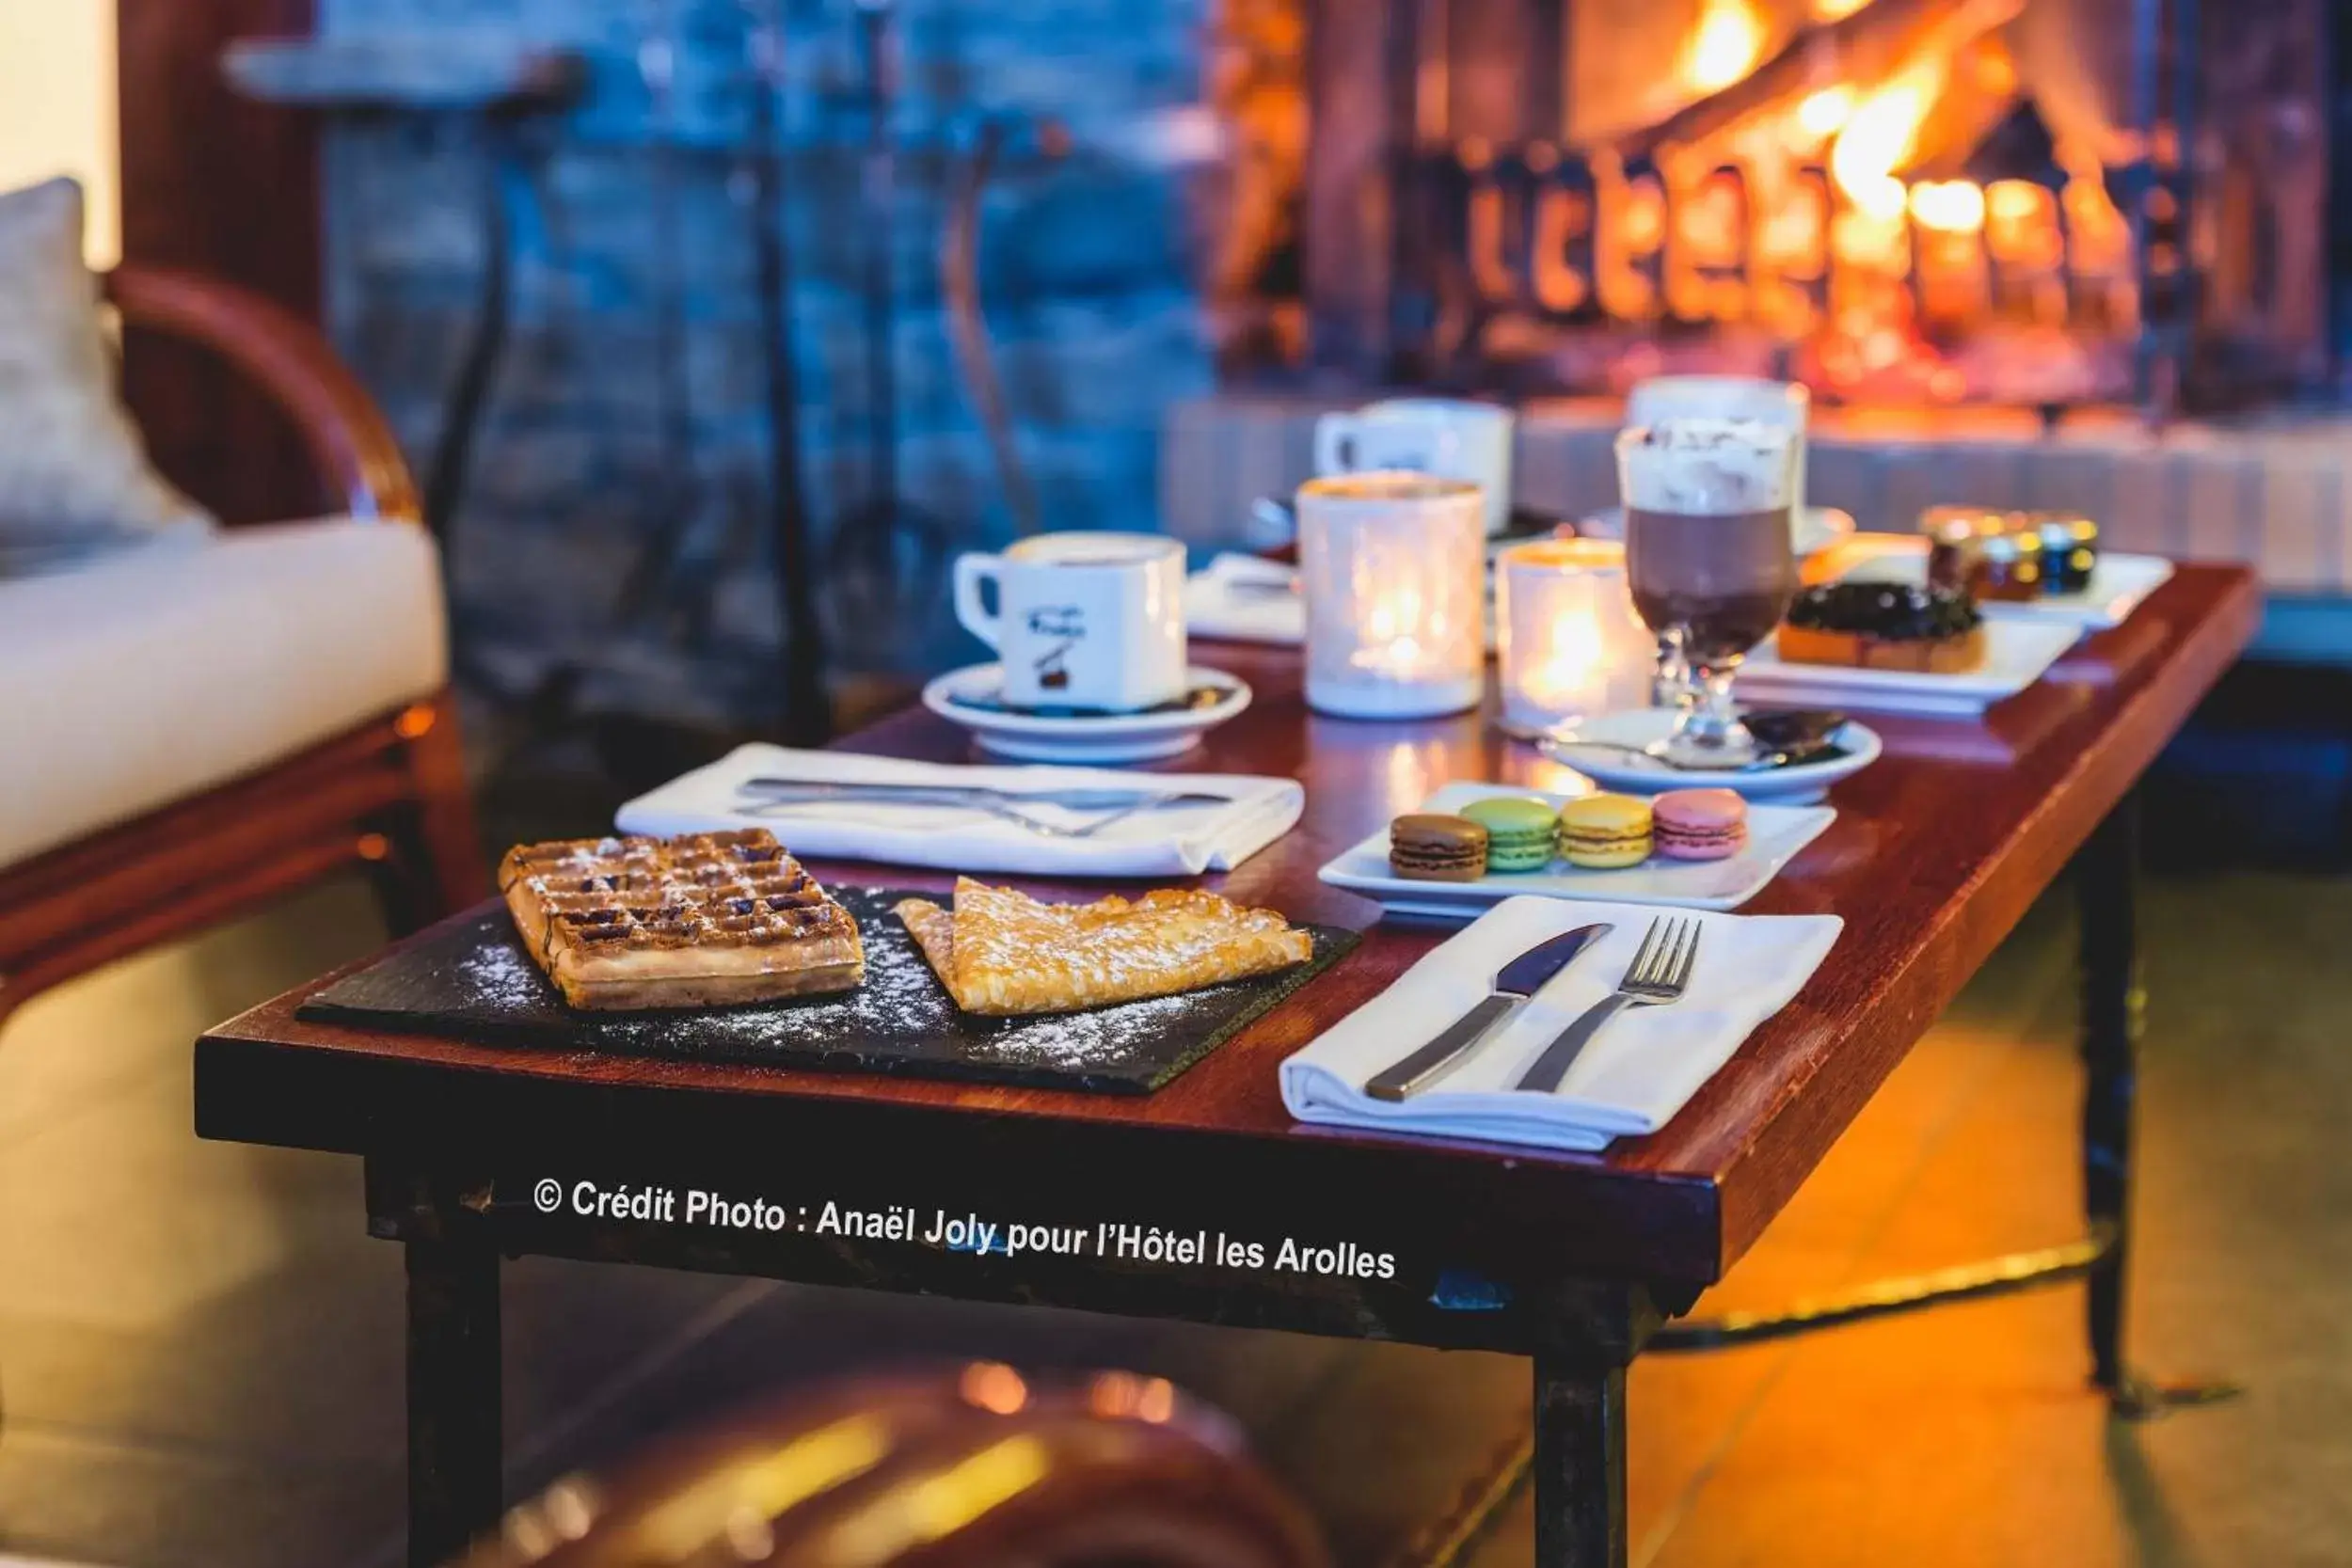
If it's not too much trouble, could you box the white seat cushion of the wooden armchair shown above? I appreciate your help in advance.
[0,522,450,865]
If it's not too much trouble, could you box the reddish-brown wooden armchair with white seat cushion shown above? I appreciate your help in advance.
[0,265,485,1021]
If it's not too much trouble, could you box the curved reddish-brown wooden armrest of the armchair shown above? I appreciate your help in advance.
[106,263,423,522]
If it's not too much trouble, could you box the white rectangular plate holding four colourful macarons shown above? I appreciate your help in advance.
[1322,783,1837,919]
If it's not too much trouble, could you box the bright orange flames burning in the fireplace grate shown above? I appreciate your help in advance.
[1555,0,2138,402]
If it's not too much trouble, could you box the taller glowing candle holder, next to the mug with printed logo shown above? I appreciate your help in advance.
[1298,470,1486,720]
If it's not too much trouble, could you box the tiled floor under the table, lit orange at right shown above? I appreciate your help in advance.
[0,875,2352,1568]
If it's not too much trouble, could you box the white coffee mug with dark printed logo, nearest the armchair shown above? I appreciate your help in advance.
[955,533,1185,712]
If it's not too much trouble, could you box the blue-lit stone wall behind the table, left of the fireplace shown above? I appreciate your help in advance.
[318,0,1212,720]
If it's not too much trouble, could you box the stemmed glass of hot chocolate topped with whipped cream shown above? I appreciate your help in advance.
[1616,416,1802,768]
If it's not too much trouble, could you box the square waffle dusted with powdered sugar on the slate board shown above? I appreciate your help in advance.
[499,828,866,1008]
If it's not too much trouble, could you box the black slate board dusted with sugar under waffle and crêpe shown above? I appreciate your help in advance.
[299,886,1358,1093]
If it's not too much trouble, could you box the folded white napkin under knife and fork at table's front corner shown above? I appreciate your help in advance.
[1282,898,1847,1149]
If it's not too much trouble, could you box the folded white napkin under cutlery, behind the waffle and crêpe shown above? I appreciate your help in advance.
[616,745,1308,877]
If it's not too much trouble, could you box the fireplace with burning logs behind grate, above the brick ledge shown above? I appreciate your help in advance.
[1223,0,2341,414]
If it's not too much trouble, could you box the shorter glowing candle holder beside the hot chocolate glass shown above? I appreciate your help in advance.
[1494,538,1659,738]
